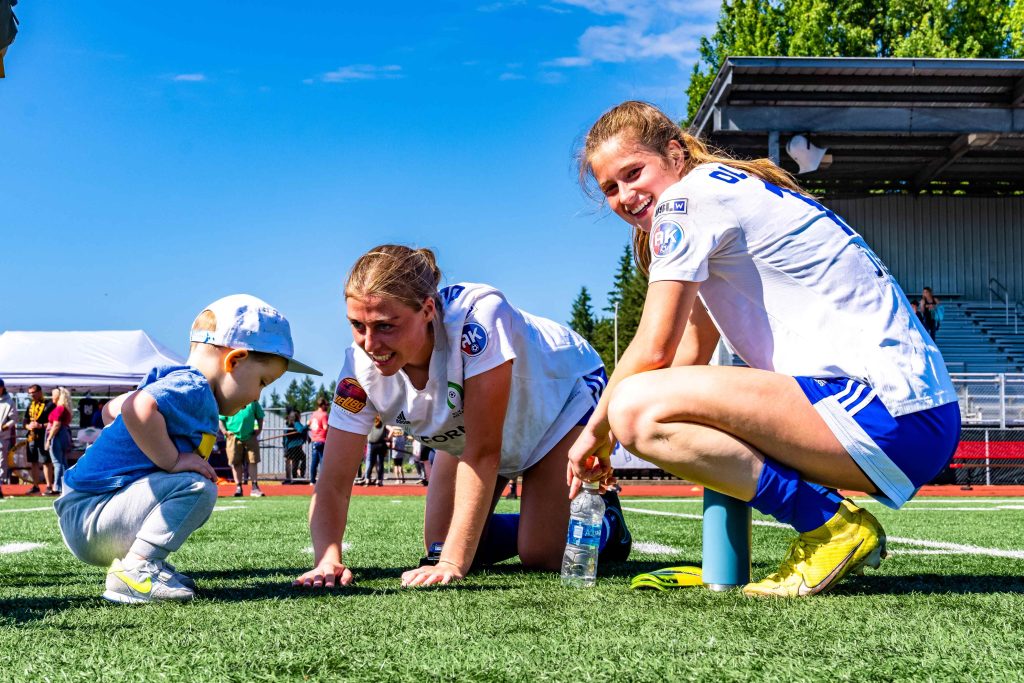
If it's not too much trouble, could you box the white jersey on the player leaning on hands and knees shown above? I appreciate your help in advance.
[330,283,604,475]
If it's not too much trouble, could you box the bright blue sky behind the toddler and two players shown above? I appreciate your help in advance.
[0,0,720,393]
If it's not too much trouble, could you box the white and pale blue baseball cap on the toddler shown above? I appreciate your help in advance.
[188,294,324,376]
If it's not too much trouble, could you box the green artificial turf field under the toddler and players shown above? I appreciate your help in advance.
[0,498,1024,681]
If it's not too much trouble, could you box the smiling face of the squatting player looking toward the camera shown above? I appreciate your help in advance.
[590,135,683,232]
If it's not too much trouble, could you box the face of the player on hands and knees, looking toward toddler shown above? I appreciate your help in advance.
[346,295,434,376]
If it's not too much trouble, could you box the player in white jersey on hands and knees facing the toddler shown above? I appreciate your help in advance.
[295,245,632,588]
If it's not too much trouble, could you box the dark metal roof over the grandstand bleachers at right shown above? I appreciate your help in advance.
[690,57,1024,196]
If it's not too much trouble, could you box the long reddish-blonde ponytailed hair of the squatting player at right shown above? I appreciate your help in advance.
[577,100,806,274]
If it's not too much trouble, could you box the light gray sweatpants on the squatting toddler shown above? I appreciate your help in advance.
[54,472,217,566]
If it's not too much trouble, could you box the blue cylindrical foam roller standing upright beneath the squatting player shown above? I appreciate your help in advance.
[701,488,752,591]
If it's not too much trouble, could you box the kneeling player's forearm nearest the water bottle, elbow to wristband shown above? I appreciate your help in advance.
[440,452,501,572]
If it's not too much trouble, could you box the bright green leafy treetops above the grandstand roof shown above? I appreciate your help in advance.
[686,0,1024,121]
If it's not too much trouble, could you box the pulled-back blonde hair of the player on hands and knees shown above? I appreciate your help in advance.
[345,245,441,311]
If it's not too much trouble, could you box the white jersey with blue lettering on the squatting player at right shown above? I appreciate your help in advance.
[650,164,956,416]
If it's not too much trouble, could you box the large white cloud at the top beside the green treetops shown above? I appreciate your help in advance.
[546,0,721,68]
